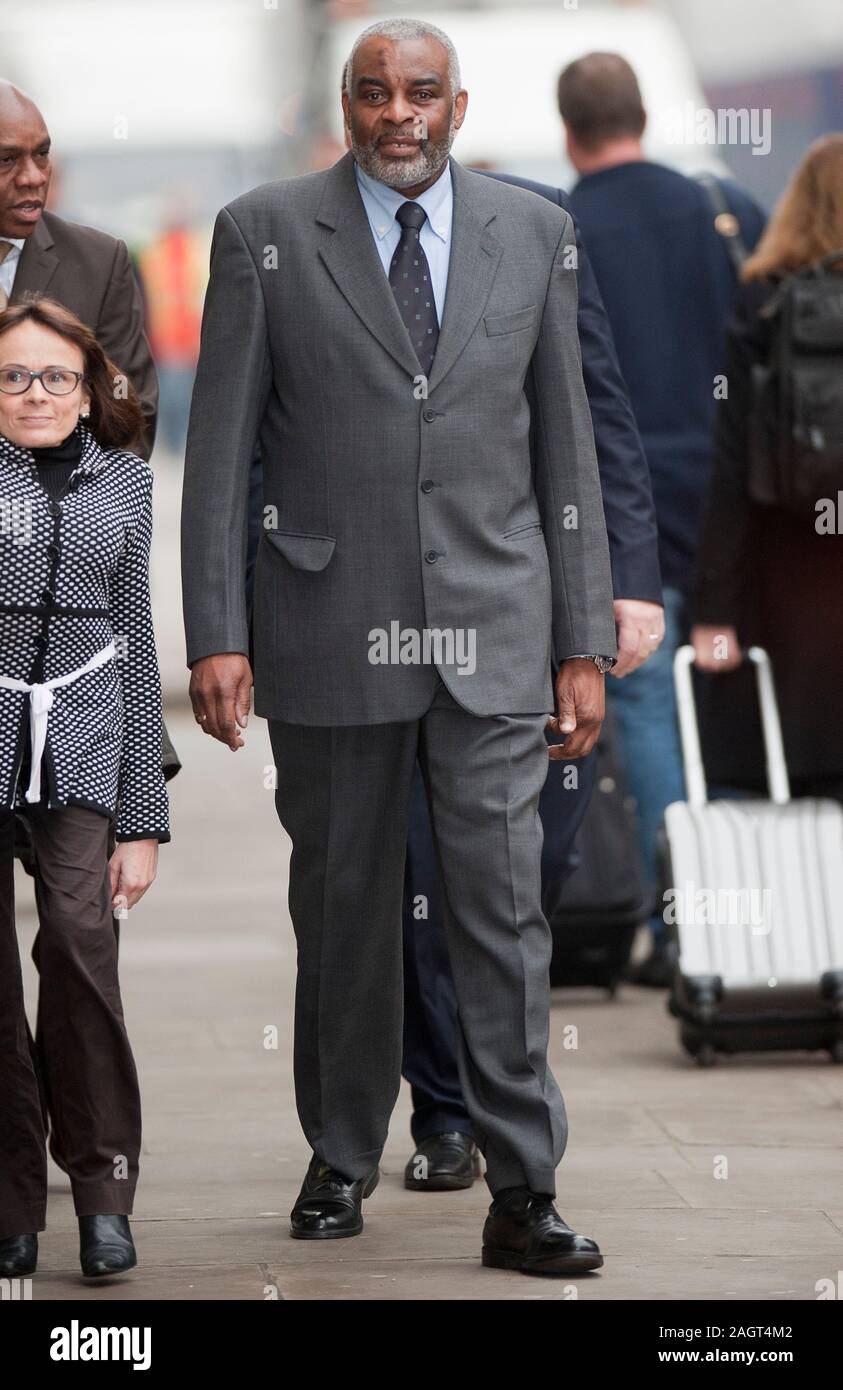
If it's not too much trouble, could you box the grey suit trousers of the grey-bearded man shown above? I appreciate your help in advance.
[268,680,568,1194]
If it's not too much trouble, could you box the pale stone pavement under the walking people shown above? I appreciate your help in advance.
[18,708,843,1301]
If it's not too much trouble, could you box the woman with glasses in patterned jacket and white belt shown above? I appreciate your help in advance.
[0,297,170,1276]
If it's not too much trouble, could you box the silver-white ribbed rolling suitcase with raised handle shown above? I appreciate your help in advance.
[662,646,843,1066]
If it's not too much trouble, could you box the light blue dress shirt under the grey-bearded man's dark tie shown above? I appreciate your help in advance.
[355,161,453,327]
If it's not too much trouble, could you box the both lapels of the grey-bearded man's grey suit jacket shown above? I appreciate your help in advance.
[316,152,504,392]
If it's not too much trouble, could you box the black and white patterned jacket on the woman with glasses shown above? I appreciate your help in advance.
[0,421,170,841]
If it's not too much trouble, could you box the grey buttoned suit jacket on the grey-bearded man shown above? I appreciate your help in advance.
[182,154,616,724]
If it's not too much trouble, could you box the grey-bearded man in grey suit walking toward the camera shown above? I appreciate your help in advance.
[182,19,616,1275]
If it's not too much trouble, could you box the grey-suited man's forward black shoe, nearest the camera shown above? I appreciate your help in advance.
[483,1187,602,1275]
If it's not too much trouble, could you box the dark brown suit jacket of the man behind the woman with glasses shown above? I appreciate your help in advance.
[10,213,159,460]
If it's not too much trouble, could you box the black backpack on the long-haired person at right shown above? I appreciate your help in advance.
[747,250,843,513]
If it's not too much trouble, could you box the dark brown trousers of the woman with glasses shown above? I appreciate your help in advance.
[0,803,141,1240]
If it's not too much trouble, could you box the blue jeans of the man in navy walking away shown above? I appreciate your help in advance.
[607,588,686,941]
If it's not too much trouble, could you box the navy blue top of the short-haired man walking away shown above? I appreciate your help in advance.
[569,160,764,592]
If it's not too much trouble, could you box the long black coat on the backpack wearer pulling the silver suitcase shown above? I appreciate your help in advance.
[693,281,843,790]
